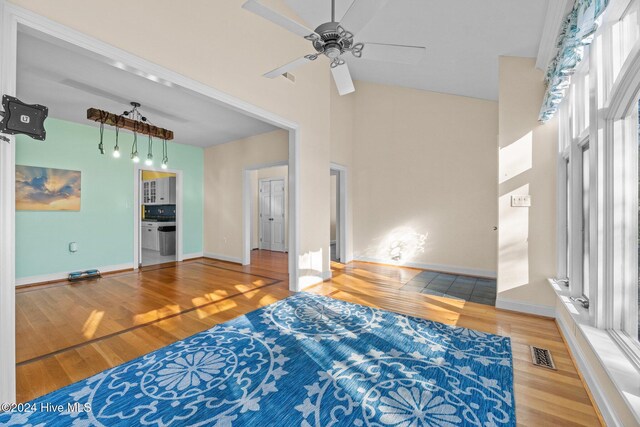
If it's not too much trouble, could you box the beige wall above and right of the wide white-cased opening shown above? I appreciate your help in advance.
[12,0,330,285]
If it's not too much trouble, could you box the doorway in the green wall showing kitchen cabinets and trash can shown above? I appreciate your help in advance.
[136,169,178,267]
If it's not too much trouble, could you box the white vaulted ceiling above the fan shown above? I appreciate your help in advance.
[285,0,554,100]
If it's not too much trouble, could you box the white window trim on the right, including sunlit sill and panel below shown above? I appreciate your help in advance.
[550,0,640,425]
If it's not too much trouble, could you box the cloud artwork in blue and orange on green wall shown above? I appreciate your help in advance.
[16,165,81,211]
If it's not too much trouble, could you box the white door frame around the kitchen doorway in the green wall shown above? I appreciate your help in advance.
[133,164,184,269]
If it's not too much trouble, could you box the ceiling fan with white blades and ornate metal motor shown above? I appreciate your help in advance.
[242,0,426,95]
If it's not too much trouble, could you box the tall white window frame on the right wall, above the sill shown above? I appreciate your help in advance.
[557,0,640,371]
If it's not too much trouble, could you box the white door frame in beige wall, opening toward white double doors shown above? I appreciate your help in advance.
[242,162,288,266]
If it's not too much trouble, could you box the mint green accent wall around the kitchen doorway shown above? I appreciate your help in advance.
[16,118,204,279]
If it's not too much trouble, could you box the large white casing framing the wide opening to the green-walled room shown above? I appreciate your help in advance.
[0,0,300,402]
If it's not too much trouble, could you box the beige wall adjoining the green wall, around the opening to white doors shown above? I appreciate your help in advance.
[204,130,288,262]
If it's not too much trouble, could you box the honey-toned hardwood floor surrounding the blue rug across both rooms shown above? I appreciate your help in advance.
[16,251,600,426]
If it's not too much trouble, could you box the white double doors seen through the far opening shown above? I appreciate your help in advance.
[259,179,285,252]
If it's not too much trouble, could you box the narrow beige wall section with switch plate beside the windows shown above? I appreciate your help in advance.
[497,57,558,314]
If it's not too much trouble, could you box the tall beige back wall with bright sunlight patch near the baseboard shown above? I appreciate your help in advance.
[350,81,498,275]
